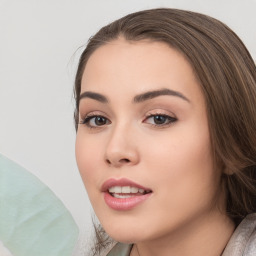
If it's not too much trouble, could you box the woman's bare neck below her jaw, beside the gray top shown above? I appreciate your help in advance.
[131,212,234,256]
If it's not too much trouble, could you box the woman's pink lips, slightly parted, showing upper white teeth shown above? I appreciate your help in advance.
[101,179,152,211]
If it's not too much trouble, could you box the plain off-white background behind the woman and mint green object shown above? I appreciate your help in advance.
[0,0,256,240]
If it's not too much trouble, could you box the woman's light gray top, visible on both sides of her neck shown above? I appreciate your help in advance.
[107,213,256,256]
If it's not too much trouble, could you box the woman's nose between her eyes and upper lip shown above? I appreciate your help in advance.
[105,124,139,168]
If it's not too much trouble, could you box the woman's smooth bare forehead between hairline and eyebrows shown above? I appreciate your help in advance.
[81,38,203,104]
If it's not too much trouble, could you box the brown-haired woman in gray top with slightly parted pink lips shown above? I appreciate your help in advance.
[75,9,256,256]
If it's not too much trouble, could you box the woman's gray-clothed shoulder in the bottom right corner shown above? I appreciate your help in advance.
[222,213,256,256]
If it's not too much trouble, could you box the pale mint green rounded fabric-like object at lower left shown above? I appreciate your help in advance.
[0,154,78,256]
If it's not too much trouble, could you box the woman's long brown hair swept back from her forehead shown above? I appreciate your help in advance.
[74,8,256,253]
